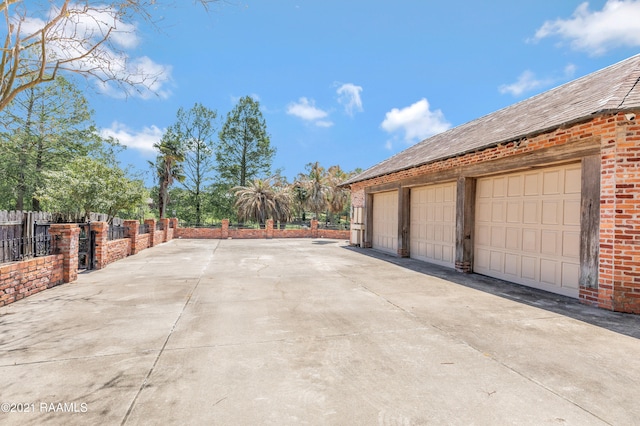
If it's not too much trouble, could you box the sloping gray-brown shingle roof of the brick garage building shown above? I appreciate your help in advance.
[343,54,640,185]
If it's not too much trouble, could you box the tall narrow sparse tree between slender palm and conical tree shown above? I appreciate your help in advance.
[173,103,218,225]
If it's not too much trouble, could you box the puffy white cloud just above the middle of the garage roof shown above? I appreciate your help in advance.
[380,98,451,147]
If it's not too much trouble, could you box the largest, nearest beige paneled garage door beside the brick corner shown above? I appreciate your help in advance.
[474,164,581,297]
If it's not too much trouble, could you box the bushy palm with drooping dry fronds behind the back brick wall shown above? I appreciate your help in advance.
[233,177,291,225]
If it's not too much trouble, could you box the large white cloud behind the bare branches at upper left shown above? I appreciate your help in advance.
[18,3,172,99]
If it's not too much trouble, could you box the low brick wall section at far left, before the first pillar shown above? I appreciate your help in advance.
[0,254,64,306]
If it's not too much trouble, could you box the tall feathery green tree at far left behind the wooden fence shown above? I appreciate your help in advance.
[0,77,115,210]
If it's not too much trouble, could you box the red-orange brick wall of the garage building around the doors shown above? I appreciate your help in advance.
[351,111,640,313]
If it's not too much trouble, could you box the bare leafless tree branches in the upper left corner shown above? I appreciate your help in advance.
[0,0,219,111]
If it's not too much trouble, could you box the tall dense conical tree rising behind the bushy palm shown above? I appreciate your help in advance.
[216,96,276,187]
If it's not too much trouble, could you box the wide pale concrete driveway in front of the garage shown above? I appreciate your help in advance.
[0,239,640,425]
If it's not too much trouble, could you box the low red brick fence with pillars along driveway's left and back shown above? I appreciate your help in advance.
[0,218,349,306]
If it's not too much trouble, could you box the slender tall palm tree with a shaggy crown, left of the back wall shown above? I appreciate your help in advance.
[152,129,185,219]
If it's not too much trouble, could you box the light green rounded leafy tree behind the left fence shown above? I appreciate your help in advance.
[35,158,148,220]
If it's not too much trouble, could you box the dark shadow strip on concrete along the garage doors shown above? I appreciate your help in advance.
[344,246,640,339]
